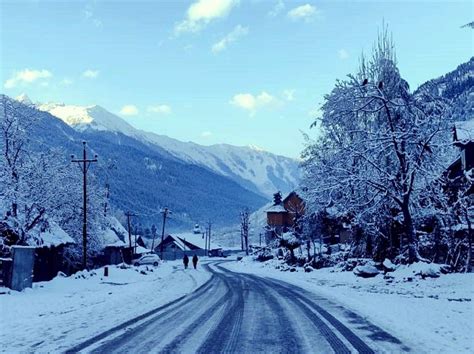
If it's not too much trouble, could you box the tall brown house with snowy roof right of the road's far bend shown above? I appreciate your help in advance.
[266,191,305,234]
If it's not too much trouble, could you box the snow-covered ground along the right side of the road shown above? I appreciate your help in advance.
[225,257,474,353]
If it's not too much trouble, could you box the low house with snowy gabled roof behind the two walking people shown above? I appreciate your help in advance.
[154,232,222,260]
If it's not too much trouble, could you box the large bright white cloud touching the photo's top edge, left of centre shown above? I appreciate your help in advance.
[174,0,239,35]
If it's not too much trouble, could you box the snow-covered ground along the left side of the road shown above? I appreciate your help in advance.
[0,261,210,353]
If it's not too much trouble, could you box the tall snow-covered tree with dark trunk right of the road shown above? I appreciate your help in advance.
[303,29,449,262]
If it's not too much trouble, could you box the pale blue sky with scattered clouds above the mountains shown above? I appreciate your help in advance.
[0,0,474,157]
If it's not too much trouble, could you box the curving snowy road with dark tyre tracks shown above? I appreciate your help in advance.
[70,262,409,353]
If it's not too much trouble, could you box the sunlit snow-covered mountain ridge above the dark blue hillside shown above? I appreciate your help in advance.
[31,95,299,197]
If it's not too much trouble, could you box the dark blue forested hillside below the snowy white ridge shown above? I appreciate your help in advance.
[3,96,265,229]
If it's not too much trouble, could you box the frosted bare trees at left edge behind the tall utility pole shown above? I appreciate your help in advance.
[0,95,106,262]
